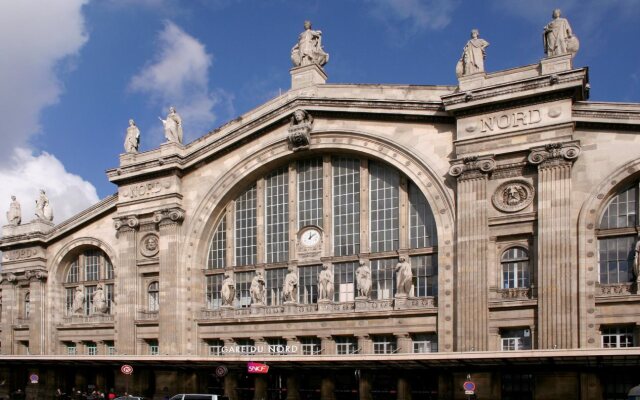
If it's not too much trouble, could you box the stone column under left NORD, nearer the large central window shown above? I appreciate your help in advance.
[153,208,188,355]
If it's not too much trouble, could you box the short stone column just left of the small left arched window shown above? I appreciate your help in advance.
[24,269,47,355]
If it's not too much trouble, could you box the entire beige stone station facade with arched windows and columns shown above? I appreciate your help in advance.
[0,21,640,400]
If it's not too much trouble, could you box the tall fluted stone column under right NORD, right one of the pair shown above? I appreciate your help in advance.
[528,142,580,349]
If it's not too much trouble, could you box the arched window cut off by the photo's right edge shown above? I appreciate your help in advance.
[597,181,640,285]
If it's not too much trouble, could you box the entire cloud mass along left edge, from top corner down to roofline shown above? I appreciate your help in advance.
[0,0,98,225]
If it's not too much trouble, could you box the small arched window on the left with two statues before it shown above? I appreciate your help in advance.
[64,249,114,316]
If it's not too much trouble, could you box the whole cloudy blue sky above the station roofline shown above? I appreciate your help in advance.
[0,0,640,224]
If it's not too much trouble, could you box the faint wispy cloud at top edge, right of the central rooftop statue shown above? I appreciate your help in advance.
[367,0,459,37]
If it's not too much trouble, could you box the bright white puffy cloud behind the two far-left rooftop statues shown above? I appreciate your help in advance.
[0,149,98,225]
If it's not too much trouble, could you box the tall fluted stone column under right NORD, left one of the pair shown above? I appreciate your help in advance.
[449,156,496,351]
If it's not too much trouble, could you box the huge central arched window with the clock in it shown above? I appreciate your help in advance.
[205,155,438,309]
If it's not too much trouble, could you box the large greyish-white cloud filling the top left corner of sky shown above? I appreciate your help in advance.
[0,0,88,161]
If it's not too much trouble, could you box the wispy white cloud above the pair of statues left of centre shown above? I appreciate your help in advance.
[129,21,224,140]
